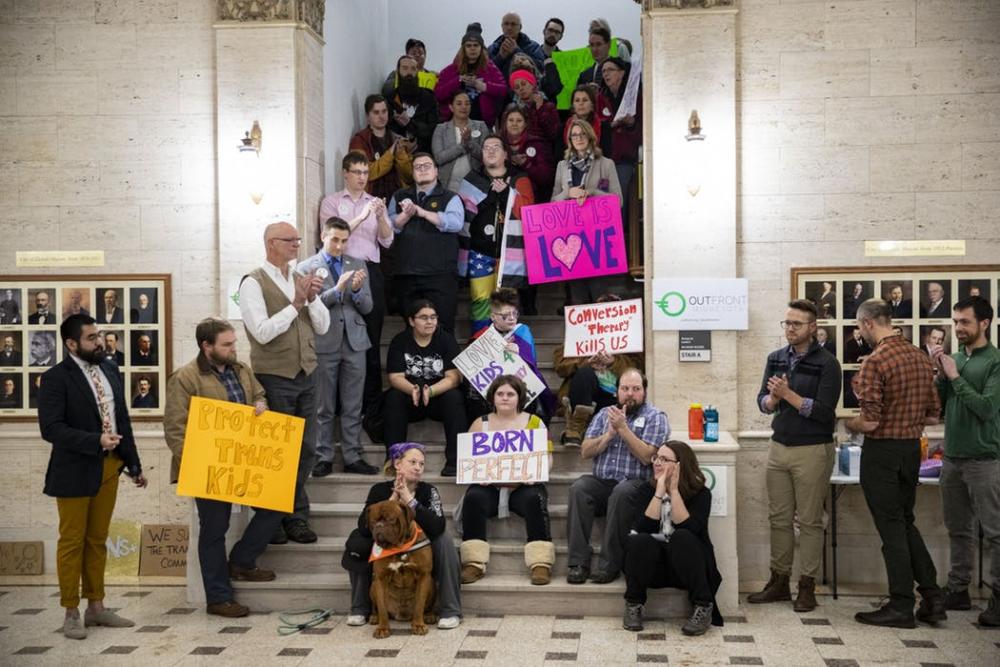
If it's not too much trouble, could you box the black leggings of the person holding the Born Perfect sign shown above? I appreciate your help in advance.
[462,484,552,542]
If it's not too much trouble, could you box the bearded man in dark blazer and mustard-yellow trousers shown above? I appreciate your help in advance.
[38,314,146,639]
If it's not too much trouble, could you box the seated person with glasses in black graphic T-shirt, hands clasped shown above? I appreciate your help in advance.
[383,299,467,477]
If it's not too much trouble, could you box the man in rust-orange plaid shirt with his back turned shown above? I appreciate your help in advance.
[847,299,947,628]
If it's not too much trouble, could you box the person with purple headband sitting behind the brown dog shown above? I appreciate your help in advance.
[341,442,462,630]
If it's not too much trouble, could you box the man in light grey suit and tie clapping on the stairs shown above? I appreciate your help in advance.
[295,217,378,477]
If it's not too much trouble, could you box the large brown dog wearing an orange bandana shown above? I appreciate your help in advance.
[368,500,436,639]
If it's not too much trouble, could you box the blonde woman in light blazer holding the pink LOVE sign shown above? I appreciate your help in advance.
[552,118,622,304]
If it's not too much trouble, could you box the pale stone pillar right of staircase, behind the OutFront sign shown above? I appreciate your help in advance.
[642,0,738,430]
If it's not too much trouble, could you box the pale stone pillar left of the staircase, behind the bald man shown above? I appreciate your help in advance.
[215,0,324,315]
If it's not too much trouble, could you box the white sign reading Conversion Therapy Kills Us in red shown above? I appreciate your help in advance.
[563,299,643,357]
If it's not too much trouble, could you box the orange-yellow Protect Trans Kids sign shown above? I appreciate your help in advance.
[177,396,306,512]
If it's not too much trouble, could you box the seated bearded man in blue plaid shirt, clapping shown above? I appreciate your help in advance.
[566,368,670,584]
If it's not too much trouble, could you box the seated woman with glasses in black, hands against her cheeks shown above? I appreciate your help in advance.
[622,440,722,635]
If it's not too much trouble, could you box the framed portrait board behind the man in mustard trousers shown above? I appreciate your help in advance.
[0,274,171,421]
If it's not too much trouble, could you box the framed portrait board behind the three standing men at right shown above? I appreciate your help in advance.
[792,266,1000,417]
